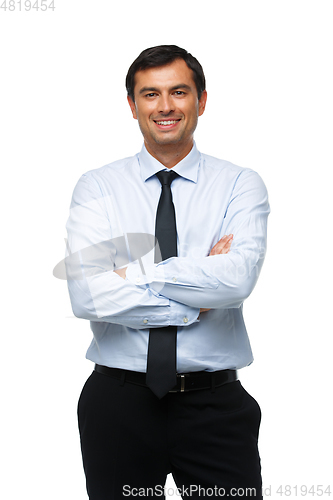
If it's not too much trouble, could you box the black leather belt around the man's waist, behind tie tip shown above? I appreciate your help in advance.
[95,365,237,392]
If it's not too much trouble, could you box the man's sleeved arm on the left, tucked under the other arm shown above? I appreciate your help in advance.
[67,175,199,329]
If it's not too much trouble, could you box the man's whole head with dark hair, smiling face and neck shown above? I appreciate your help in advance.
[126,45,207,166]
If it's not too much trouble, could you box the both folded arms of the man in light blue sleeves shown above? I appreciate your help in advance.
[67,166,269,329]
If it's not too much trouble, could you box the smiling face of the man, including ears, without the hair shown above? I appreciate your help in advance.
[128,59,207,152]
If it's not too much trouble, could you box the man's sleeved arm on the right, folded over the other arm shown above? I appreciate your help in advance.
[126,169,270,309]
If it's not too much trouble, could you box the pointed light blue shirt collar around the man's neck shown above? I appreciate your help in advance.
[138,142,200,182]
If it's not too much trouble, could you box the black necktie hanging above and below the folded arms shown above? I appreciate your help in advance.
[146,170,178,398]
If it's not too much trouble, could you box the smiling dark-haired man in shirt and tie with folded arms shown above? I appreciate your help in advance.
[67,45,269,500]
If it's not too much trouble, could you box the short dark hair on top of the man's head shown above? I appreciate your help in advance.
[126,45,206,101]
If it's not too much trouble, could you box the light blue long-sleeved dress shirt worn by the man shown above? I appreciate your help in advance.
[67,144,269,373]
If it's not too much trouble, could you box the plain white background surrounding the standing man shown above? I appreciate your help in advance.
[0,0,333,500]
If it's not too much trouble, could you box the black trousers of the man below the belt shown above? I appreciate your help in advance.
[78,371,262,500]
